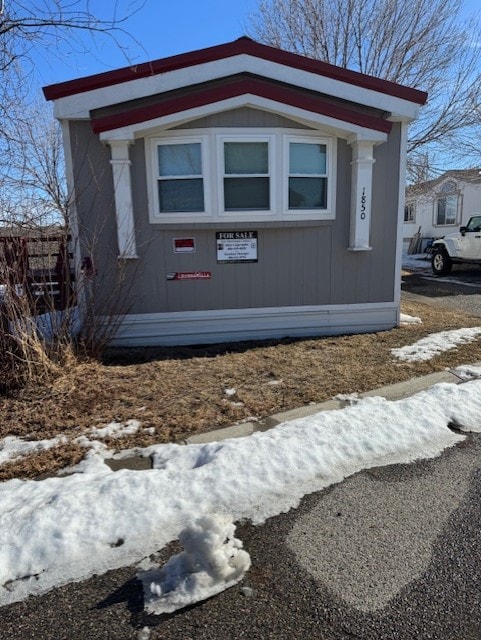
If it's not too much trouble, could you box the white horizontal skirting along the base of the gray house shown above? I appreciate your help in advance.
[104,302,399,347]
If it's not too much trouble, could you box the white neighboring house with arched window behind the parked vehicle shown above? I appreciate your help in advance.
[403,169,481,249]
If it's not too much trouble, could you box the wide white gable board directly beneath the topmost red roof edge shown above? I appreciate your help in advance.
[54,54,419,121]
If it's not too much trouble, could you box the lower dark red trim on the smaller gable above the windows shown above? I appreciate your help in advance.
[92,78,392,133]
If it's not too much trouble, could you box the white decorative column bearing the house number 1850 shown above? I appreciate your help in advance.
[349,138,376,251]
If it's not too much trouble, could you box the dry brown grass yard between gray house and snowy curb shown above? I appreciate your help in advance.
[0,302,481,480]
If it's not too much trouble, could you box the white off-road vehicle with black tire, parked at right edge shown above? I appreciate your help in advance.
[431,213,481,276]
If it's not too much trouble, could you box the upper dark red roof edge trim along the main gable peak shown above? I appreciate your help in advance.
[43,37,427,104]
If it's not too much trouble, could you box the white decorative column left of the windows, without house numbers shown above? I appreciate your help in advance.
[108,140,138,259]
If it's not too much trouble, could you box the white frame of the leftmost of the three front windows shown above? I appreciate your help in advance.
[147,135,212,222]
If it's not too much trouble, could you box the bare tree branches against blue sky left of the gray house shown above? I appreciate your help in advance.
[0,0,145,226]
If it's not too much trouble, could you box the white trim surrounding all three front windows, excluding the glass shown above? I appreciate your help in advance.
[145,128,337,224]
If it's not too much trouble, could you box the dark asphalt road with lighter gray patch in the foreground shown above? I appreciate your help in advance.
[0,434,481,640]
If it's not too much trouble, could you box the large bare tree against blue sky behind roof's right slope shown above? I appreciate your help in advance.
[248,0,481,170]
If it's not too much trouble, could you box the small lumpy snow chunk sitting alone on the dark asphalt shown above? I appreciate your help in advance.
[139,515,251,614]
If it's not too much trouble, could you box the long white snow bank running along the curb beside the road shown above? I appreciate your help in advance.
[0,380,481,605]
